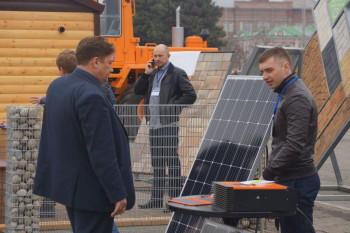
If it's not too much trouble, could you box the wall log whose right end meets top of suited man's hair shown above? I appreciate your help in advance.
[0,39,80,50]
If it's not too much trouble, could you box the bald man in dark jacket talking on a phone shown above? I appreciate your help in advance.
[135,44,197,209]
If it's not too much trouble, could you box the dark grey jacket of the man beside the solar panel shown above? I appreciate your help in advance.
[263,74,318,182]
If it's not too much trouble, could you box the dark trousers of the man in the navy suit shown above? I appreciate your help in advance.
[66,206,113,233]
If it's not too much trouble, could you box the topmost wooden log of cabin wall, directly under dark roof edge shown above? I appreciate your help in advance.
[0,11,94,22]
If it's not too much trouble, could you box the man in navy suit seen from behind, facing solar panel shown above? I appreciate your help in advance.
[34,36,135,233]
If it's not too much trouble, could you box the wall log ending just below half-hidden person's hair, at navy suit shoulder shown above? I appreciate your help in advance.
[0,75,58,86]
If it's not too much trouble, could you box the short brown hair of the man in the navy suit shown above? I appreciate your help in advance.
[76,36,115,65]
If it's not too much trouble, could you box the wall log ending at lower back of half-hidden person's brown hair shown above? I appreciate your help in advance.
[0,66,60,76]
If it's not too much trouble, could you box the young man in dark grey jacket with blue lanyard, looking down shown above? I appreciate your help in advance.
[259,47,320,233]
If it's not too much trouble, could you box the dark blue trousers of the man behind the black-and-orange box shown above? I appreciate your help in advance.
[279,174,320,233]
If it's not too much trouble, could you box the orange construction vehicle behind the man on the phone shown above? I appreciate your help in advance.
[94,0,218,104]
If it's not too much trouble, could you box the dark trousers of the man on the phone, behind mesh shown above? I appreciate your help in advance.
[150,126,181,201]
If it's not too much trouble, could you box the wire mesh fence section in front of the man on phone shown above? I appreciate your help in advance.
[116,105,215,232]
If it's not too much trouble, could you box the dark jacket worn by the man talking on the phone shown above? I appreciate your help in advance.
[135,63,197,125]
